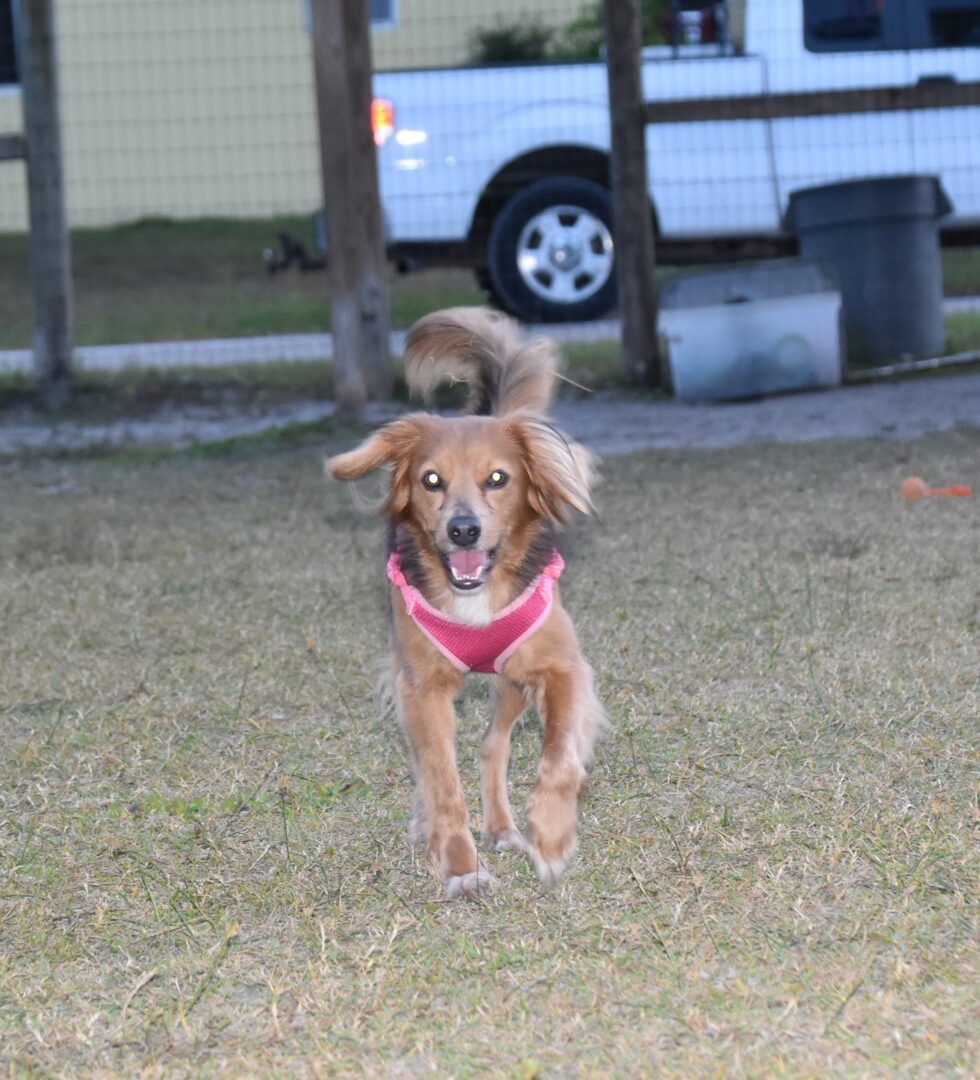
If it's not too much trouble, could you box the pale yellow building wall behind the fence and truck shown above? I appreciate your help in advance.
[0,0,581,231]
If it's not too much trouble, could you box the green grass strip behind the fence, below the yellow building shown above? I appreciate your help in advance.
[0,217,980,349]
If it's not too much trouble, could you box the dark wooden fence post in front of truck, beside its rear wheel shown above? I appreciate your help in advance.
[603,0,660,384]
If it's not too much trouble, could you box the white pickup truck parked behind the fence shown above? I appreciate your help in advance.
[373,0,980,321]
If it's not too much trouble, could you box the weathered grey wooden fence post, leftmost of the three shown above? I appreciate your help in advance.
[15,0,72,408]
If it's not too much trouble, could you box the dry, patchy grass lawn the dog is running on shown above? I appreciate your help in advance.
[0,428,980,1078]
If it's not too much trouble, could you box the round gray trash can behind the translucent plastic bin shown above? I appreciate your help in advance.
[787,176,952,365]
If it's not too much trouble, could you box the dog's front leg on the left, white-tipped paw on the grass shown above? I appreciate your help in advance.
[397,674,497,900]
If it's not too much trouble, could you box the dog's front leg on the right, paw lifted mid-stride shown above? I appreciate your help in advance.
[527,663,601,885]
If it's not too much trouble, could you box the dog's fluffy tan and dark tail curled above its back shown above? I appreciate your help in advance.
[405,308,558,416]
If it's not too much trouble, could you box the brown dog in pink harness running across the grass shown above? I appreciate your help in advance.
[327,308,604,897]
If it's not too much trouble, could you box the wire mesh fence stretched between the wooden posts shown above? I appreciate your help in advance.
[0,0,980,367]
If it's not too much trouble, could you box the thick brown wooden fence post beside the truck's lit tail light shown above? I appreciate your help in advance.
[311,0,391,413]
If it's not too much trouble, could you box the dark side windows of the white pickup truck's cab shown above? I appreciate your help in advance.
[803,0,980,53]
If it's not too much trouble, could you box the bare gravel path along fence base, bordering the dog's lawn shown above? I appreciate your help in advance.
[0,372,980,456]
